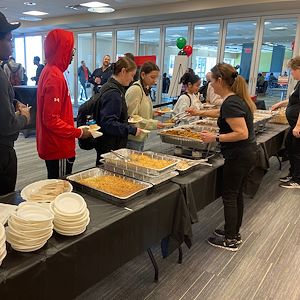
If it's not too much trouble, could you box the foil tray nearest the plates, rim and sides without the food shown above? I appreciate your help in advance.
[66,168,152,205]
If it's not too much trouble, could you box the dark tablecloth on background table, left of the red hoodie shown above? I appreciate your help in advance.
[14,85,37,129]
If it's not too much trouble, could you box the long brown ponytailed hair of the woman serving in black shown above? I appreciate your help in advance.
[211,63,256,113]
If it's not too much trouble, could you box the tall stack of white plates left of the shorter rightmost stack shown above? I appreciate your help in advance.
[6,202,54,252]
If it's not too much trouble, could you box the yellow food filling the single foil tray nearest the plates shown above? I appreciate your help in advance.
[79,175,144,198]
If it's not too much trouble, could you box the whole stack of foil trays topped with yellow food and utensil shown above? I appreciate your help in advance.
[101,149,179,185]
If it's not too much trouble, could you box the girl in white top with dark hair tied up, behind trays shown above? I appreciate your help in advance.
[173,72,201,122]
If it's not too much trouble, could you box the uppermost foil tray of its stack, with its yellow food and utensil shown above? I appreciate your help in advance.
[101,148,178,176]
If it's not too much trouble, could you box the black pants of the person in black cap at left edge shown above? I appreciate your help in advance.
[0,145,17,196]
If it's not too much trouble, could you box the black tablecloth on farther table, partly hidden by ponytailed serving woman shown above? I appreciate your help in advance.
[172,124,289,219]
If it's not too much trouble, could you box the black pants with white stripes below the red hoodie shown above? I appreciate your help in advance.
[45,157,75,179]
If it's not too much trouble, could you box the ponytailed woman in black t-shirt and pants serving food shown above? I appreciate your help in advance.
[188,63,256,251]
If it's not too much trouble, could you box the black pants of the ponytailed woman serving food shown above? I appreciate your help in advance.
[222,145,257,239]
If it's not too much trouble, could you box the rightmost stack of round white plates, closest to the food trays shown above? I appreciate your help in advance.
[50,193,90,236]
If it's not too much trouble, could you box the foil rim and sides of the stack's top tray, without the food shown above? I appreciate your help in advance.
[101,148,178,176]
